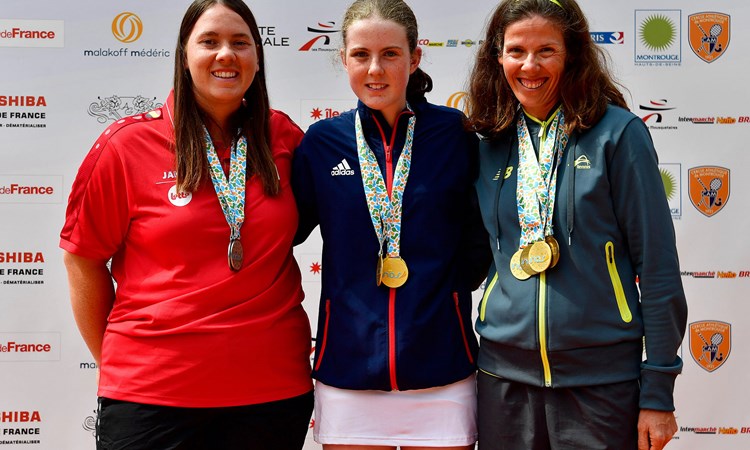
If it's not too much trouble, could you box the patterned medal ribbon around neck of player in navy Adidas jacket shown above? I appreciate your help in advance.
[354,109,417,257]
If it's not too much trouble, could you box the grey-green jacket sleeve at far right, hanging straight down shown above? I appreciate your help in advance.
[609,117,687,411]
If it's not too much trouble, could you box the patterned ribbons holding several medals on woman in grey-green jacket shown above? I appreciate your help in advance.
[516,108,568,248]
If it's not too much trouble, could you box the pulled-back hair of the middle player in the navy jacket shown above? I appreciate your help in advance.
[341,0,432,102]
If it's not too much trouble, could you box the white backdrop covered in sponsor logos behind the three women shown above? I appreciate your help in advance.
[0,0,750,450]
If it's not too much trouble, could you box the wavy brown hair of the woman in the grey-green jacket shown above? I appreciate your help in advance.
[468,0,628,138]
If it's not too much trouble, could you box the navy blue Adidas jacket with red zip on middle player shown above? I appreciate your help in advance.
[293,101,490,390]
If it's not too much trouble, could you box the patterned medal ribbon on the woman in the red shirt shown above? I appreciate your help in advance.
[204,128,247,240]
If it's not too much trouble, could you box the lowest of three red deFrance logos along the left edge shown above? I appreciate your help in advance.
[0,333,60,362]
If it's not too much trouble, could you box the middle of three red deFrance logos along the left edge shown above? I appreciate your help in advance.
[0,175,63,203]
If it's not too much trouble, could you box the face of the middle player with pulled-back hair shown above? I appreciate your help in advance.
[341,17,422,125]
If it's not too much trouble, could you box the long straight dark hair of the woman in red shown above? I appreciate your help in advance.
[174,0,279,196]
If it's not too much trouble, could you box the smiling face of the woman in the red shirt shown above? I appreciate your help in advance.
[185,4,259,113]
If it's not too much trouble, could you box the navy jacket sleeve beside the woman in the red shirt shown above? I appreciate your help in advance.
[292,132,319,245]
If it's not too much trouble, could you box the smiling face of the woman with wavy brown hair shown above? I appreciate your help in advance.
[498,16,565,120]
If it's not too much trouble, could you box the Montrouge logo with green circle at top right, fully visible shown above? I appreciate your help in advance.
[634,9,682,66]
